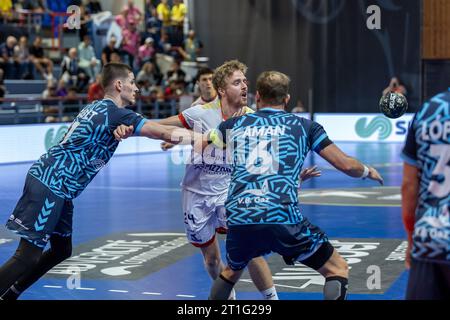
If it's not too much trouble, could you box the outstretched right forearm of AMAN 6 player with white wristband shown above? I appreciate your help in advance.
[319,143,383,185]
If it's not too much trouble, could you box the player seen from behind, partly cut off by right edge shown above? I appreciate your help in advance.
[402,91,450,300]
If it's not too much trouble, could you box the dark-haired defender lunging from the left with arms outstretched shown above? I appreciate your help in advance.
[0,63,181,299]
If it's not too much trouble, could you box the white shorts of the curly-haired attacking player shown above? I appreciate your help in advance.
[182,189,227,247]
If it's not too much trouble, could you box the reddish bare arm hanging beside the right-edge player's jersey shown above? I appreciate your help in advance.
[402,162,419,268]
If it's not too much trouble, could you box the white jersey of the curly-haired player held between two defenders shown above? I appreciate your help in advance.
[178,99,253,196]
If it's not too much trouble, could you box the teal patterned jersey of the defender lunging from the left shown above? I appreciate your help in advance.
[28,99,146,199]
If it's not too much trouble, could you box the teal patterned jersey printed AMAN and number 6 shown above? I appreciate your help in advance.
[212,108,332,225]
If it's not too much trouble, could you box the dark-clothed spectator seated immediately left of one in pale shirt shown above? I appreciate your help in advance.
[61,48,89,92]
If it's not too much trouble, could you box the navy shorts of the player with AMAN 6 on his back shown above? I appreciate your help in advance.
[226,218,333,270]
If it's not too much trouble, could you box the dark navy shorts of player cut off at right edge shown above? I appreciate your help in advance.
[406,258,450,300]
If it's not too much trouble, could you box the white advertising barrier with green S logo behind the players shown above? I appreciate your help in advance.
[0,114,413,163]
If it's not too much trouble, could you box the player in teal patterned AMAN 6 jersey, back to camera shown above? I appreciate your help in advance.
[207,71,383,300]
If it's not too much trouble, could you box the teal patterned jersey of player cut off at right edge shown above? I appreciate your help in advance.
[402,91,450,263]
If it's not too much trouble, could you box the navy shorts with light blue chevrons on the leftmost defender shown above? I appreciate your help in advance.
[6,174,73,248]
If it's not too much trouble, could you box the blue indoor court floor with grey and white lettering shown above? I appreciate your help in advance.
[0,142,407,300]
